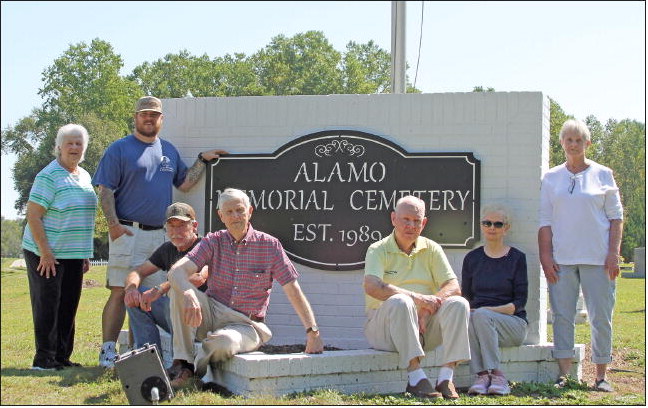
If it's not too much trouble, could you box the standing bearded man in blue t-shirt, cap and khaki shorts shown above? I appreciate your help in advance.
[92,96,226,368]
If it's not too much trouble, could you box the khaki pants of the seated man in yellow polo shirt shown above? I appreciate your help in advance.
[365,294,470,367]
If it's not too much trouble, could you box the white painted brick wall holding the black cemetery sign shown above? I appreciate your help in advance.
[161,92,549,348]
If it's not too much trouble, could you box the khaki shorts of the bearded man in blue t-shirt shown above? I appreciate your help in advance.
[106,225,166,288]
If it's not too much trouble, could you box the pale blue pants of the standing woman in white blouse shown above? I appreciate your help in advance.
[549,265,616,364]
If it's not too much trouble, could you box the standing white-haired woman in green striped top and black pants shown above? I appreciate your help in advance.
[22,124,97,370]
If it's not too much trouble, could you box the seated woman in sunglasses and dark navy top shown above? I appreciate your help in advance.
[461,205,528,395]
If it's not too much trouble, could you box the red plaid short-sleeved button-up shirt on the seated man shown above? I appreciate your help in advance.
[187,225,299,318]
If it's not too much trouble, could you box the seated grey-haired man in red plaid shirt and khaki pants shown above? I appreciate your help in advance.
[169,188,324,387]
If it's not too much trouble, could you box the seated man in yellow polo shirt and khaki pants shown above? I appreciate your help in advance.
[364,196,470,399]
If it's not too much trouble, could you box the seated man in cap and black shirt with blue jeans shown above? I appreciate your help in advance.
[124,203,207,365]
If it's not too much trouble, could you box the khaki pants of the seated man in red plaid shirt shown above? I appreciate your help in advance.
[169,287,272,363]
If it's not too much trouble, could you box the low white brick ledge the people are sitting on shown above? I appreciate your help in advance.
[118,330,585,396]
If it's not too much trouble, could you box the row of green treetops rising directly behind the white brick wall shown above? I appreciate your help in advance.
[129,31,420,98]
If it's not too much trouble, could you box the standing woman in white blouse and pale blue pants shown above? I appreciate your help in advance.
[538,119,623,391]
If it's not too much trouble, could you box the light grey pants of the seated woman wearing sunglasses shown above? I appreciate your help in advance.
[468,308,527,374]
